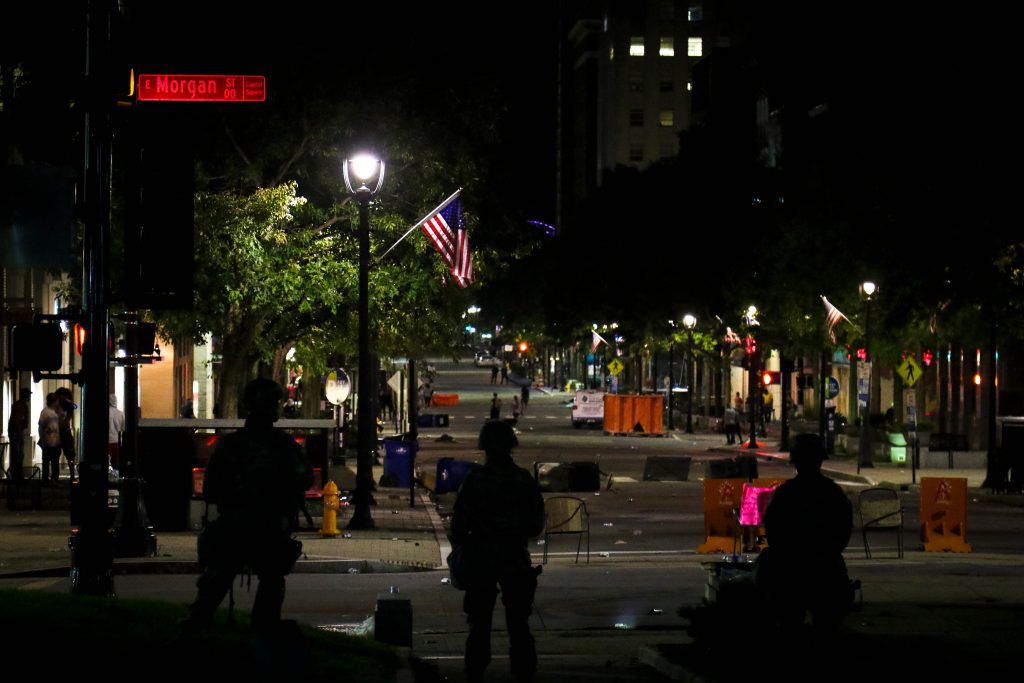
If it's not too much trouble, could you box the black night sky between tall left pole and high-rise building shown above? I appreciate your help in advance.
[123,0,557,220]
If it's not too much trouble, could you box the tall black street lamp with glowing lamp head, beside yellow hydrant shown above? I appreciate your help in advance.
[343,154,384,529]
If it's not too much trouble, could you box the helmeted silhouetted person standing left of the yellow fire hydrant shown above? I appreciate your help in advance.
[182,380,313,638]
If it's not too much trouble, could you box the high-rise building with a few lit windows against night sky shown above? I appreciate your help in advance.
[558,0,741,229]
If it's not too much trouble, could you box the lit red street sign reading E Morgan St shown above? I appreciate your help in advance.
[136,74,266,102]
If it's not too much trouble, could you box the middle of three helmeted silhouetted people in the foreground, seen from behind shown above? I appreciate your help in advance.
[450,421,544,683]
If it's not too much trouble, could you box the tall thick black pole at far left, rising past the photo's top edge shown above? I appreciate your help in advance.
[71,0,114,596]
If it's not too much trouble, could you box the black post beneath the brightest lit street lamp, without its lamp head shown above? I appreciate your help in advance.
[347,197,377,529]
